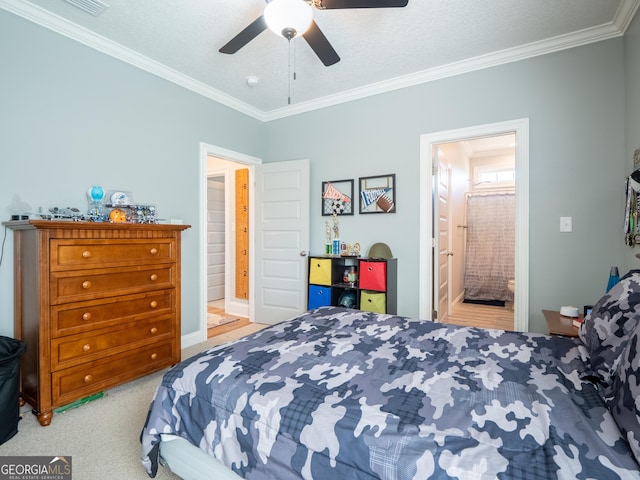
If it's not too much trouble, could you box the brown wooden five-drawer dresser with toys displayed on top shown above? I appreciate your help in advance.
[5,220,189,426]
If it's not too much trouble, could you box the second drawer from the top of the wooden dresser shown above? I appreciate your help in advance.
[50,265,175,305]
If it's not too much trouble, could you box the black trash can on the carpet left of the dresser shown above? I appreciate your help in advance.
[0,335,27,445]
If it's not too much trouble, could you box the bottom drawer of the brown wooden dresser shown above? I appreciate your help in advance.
[51,339,180,407]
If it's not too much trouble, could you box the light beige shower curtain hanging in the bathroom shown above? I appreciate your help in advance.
[464,193,516,304]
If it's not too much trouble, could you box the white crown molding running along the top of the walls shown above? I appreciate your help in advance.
[0,0,640,122]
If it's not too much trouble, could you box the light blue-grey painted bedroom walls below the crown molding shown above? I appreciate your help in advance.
[0,11,640,335]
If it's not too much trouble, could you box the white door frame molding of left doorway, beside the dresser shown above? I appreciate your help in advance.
[194,142,262,347]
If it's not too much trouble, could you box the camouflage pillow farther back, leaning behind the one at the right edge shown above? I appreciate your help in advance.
[578,270,640,401]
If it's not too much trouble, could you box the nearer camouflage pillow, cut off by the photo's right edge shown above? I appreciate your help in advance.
[609,332,640,462]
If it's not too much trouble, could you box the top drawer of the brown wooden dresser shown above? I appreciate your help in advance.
[50,239,175,271]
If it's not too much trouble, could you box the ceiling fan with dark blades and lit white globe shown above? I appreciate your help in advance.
[219,0,409,67]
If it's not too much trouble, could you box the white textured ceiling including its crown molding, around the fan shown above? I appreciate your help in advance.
[0,0,640,120]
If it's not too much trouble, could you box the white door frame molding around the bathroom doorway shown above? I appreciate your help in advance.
[419,118,529,332]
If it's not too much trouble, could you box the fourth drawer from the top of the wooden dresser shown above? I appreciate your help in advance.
[51,316,173,371]
